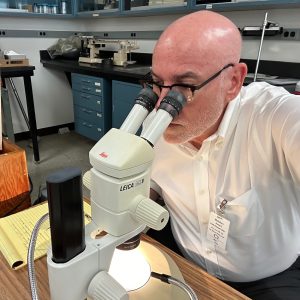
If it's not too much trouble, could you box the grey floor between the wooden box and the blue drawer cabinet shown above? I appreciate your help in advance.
[17,131,95,202]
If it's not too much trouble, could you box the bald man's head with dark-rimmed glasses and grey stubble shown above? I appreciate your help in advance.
[152,11,247,148]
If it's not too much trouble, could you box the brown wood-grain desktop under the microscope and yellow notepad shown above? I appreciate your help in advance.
[0,235,249,300]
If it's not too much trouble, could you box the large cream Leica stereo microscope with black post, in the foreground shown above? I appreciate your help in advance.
[47,88,186,300]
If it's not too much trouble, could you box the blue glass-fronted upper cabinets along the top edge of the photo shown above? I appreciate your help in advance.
[0,0,300,18]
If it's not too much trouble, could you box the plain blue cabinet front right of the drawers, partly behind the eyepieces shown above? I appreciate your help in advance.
[112,80,142,128]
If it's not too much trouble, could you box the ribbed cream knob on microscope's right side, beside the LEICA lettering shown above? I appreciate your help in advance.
[135,198,169,230]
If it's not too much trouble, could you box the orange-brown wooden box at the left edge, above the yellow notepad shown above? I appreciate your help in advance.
[0,139,31,218]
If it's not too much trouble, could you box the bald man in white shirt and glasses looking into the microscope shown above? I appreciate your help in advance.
[149,11,300,300]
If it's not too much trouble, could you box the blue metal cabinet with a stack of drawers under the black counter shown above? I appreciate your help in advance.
[72,73,112,141]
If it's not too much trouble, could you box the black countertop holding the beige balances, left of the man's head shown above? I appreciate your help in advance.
[41,59,150,83]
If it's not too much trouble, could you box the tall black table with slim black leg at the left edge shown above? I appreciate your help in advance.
[0,66,40,163]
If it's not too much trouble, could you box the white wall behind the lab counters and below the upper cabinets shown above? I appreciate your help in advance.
[0,9,300,132]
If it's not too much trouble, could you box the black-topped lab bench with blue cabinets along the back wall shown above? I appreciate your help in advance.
[41,54,300,140]
